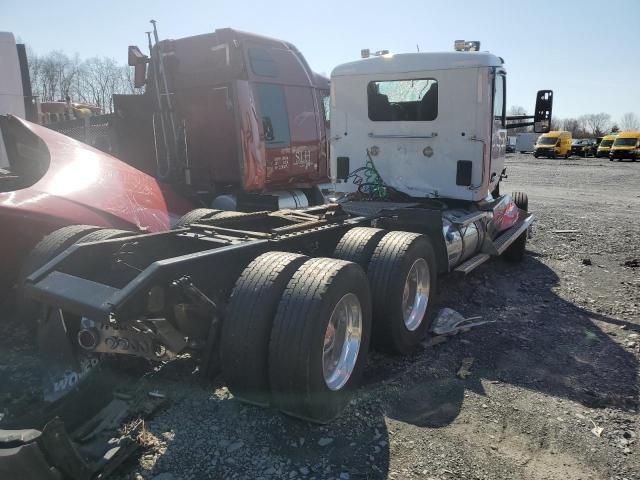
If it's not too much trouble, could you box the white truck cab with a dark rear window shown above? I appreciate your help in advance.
[331,52,507,201]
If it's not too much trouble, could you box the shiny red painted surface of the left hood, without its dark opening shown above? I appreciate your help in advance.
[0,117,193,232]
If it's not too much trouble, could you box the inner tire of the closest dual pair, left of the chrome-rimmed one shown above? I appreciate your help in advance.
[220,252,309,406]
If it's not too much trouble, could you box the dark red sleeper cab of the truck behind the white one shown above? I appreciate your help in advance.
[114,28,329,208]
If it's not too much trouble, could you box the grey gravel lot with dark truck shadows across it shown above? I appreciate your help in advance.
[0,155,640,480]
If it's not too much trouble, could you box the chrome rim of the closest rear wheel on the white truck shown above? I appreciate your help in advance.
[322,293,362,391]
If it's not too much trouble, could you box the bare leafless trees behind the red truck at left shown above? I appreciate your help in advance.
[27,48,140,113]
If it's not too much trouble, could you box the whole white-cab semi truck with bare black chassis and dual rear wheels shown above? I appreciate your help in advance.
[26,42,552,423]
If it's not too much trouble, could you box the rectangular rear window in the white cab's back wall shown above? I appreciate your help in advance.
[367,78,438,122]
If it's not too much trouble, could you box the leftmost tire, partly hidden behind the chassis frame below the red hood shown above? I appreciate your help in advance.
[16,225,100,332]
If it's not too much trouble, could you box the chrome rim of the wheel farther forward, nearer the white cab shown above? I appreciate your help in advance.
[402,258,431,331]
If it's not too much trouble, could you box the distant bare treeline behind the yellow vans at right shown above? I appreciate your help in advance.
[509,106,640,138]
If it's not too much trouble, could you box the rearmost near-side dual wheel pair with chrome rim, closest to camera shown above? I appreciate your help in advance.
[222,252,371,423]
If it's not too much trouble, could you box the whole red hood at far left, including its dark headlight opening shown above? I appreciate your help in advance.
[0,116,193,288]
